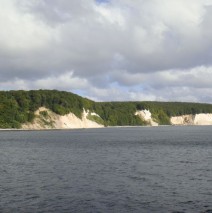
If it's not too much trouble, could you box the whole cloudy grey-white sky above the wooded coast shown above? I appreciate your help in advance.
[0,0,212,103]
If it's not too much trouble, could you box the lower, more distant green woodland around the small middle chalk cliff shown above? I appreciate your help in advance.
[94,101,212,126]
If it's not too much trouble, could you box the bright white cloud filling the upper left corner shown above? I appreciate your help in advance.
[0,0,54,51]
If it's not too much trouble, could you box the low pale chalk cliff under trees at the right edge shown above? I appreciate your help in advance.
[170,113,212,125]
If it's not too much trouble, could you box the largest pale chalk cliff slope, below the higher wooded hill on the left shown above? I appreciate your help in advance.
[22,107,104,129]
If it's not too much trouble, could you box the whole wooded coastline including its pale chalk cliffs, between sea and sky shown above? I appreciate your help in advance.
[0,90,212,129]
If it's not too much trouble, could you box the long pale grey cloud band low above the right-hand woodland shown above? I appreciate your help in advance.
[111,66,212,89]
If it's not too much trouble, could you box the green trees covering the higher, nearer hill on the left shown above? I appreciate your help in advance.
[0,90,93,128]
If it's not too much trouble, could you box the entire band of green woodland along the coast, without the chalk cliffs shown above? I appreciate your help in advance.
[0,90,212,128]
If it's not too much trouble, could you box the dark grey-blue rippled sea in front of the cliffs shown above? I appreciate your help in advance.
[0,127,212,213]
